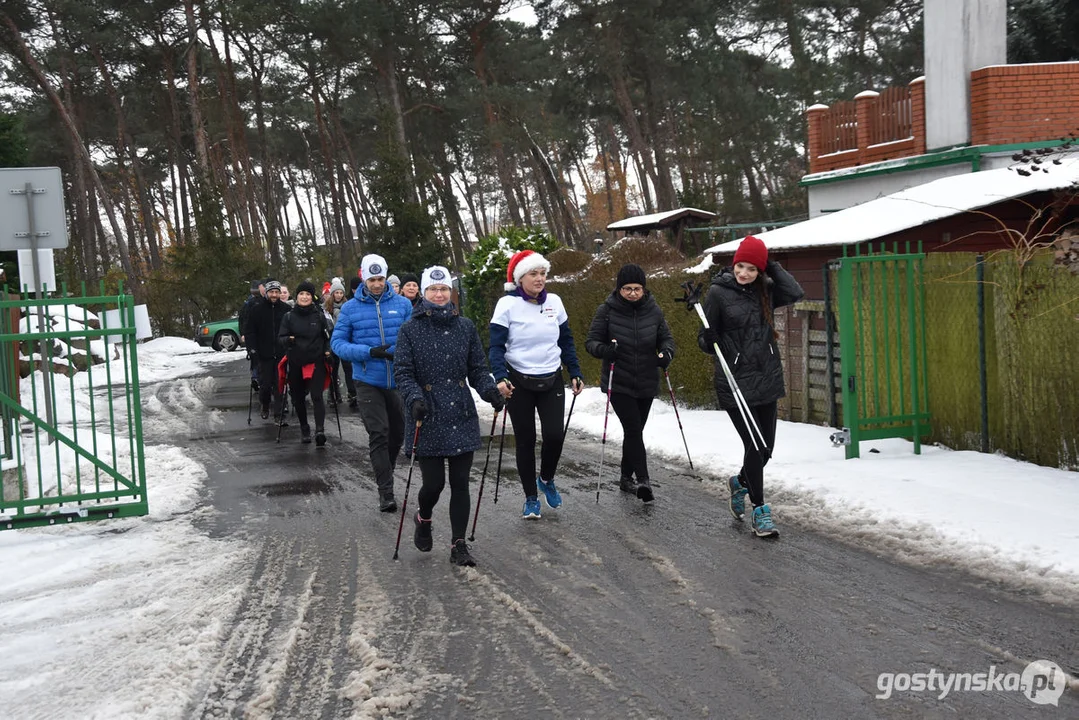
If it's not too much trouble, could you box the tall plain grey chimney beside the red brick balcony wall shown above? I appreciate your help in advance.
[923,0,1008,152]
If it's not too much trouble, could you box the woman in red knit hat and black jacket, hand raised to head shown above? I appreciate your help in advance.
[697,235,805,538]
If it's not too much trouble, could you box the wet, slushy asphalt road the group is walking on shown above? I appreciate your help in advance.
[149,361,1079,719]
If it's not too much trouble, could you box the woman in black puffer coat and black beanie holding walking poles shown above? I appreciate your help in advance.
[585,263,674,502]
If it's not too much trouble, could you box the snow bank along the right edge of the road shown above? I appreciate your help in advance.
[571,388,1079,602]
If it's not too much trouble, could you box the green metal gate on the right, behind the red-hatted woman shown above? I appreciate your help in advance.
[831,243,929,459]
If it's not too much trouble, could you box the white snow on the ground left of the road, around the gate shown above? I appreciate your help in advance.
[0,338,249,718]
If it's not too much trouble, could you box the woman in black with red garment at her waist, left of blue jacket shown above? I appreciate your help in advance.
[277,282,330,447]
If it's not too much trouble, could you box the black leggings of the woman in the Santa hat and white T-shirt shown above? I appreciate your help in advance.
[506,384,565,497]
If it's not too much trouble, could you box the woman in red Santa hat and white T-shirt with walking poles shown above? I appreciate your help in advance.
[490,250,585,519]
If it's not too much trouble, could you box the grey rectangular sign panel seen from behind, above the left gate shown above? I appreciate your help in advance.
[0,167,68,250]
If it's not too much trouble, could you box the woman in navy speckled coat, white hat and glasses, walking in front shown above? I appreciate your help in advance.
[394,266,505,566]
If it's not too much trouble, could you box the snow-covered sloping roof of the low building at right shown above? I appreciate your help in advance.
[705,153,1079,254]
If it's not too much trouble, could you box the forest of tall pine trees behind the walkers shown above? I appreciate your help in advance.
[0,0,1079,336]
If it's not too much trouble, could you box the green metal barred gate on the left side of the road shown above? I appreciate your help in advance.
[0,285,148,530]
